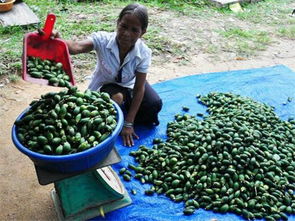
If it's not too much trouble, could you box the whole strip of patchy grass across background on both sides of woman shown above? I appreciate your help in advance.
[0,0,295,78]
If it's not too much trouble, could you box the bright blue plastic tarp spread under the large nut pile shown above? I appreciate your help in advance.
[95,65,295,221]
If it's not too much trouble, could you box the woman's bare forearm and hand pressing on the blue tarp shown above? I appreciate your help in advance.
[121,73,146,147]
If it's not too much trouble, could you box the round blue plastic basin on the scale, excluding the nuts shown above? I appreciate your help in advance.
[12,102,124,173]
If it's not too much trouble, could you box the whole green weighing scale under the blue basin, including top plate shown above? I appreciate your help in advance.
[35,147,132,221]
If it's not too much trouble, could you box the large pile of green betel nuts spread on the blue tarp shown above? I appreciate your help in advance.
[120,93,295,220]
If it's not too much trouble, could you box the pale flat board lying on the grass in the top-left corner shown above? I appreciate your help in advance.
[0,2,40,27]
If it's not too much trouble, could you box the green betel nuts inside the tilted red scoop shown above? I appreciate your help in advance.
[27,56,70,87]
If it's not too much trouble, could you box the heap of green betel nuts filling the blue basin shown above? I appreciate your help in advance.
[15,87,117,155]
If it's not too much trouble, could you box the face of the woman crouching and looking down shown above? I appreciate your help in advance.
[117,14,145,50]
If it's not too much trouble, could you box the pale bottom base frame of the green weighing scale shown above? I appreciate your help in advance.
[50,189,132,221]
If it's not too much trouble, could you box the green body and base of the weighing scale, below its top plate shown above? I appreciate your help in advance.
[51,166,132,221]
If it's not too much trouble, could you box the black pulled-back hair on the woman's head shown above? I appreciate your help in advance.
[117,3,149,30]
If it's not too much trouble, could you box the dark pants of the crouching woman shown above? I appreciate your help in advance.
[100,82,162,125]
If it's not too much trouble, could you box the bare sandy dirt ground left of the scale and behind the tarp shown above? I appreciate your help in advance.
[0,5,295,220]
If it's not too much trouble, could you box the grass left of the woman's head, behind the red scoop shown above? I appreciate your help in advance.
[0,0,126,76]
